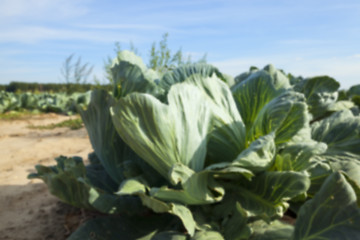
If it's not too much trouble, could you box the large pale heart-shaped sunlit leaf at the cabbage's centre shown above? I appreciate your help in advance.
[113,83,211,178]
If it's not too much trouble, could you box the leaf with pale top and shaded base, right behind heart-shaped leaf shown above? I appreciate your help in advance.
[186,75,246,162]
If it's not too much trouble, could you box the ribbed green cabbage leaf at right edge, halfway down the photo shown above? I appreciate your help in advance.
[311,110,360,154]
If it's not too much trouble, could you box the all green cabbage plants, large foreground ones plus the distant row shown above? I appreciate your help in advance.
[26,51,360,240]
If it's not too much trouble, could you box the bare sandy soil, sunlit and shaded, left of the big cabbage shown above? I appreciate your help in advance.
[0,114,92,240]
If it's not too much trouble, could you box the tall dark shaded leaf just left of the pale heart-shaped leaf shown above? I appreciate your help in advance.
[79,90,160,184]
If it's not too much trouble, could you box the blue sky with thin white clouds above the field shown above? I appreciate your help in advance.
[0,0,360,88]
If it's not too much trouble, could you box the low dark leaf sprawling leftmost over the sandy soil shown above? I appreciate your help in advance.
[29,156,143,214]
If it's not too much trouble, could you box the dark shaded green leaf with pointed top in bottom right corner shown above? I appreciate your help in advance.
[293,172,360,240]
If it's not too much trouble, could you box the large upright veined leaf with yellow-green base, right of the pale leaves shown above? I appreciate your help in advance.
[232,65,310,145]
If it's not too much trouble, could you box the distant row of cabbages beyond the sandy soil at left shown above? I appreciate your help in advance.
[0,91,90,115]
